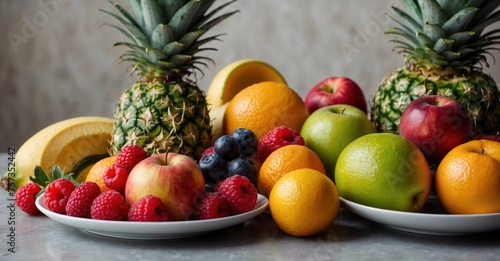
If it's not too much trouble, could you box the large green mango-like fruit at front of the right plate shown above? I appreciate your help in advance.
[335,133,431,212]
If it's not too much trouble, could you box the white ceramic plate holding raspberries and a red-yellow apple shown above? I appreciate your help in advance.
[36,192,268,239]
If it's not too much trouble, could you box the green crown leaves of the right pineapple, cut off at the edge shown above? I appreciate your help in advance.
[386,0,500,72]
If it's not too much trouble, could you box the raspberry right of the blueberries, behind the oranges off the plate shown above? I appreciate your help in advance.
[257,126,305,162]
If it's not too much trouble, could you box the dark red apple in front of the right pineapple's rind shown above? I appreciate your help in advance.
[399,95,472,165]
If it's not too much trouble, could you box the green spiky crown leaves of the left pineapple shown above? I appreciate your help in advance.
[99,0,238,78]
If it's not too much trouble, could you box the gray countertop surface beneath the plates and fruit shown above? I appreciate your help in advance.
[0,151,500,261]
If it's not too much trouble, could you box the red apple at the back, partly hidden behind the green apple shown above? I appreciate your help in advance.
[304,77,367,114]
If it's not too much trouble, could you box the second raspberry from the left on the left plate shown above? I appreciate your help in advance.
[66,181,101,218]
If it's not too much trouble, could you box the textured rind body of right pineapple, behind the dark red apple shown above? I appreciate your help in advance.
[370,68,500,135]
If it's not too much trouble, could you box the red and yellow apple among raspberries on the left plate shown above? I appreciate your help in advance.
[125,153,205,220]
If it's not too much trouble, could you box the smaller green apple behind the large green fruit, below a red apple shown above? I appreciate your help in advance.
[300,104,375,180]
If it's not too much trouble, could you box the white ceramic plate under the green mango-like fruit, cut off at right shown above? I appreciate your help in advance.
[340,198,500,235]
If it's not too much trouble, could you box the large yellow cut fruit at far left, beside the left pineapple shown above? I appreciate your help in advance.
[0,116,113,192]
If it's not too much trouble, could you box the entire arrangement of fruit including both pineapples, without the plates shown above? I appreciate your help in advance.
[2,0,500,236]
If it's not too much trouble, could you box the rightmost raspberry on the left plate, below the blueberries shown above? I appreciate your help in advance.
[216,175,257,215]
